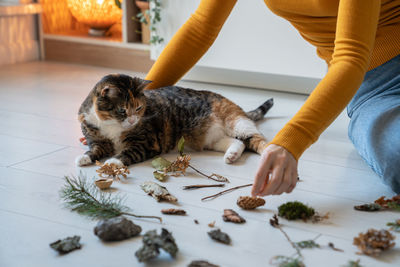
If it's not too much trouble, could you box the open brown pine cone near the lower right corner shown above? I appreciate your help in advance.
[353,229,395,256]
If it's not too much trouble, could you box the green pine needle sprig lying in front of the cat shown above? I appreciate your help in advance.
[60,174,162,222]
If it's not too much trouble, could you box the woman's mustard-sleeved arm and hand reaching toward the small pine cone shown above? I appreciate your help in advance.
[252,0,381,195]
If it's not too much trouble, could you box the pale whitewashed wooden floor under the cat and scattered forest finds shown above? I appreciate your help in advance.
[0,62,400,267]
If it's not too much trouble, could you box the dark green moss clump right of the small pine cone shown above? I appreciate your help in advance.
[278,201,315,220]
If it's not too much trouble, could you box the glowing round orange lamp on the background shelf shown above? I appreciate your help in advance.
[68,0,122,35]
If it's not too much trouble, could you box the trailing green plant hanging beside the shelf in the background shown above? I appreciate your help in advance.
[136,0,164,44]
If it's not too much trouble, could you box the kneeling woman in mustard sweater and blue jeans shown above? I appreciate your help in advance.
[146,0,400,196]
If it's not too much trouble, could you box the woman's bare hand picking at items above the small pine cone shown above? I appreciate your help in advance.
[251,144,298,196]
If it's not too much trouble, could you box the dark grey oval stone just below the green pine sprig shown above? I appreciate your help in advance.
[94,216,142,242]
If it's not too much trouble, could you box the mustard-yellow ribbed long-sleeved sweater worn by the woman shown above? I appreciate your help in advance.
[146,0,400,159]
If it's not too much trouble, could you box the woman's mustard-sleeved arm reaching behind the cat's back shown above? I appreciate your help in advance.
[146,0,236,89]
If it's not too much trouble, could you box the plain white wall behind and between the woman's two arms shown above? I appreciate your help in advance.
[152,0,326,93]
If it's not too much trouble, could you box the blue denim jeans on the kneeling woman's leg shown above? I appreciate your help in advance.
[347,55,400,194]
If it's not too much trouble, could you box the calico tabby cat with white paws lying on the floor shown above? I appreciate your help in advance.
[75,74,273,166]
